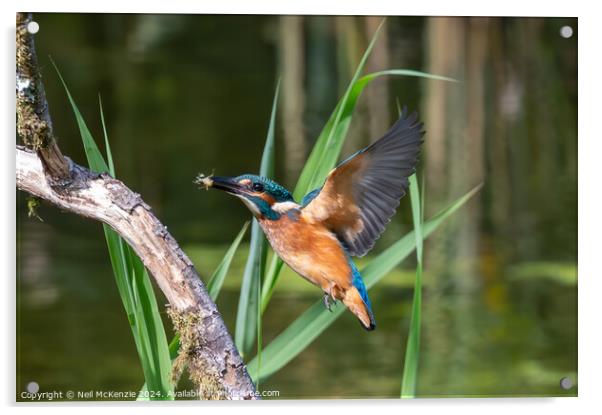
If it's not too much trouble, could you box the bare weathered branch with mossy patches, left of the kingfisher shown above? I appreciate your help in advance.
[16,14,257,399]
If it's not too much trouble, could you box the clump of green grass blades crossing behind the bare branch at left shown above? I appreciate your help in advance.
[52,62,173,400]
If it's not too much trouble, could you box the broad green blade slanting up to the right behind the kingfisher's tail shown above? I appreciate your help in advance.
[247,185,481,381]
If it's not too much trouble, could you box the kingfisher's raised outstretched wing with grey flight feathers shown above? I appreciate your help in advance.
[302,108,424,256]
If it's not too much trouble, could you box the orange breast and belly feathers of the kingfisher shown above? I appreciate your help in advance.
[259,211,352,300]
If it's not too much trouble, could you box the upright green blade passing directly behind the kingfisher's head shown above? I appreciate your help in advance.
[234,81,280,357]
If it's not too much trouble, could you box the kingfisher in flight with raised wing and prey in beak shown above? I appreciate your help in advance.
[195,108,424,330]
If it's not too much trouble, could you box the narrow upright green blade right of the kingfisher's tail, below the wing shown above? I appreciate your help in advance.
[401,174,424,398]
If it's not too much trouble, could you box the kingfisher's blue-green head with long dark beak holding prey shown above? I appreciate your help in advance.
[195,174,299,220]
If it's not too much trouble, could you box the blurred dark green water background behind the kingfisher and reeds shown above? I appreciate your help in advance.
[17,14,577,399]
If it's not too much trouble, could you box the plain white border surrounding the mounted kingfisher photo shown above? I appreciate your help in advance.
[0,0,602,415]
